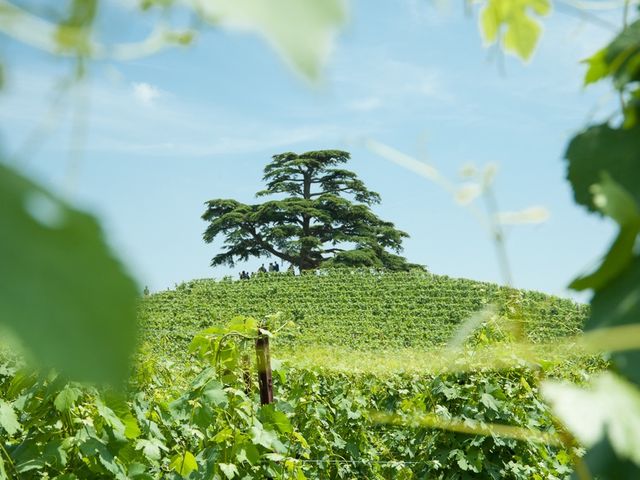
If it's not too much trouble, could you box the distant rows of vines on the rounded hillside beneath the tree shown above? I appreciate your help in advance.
[140,272,588,364]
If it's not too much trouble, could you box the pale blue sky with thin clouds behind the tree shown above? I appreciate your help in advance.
[0,0,632,298]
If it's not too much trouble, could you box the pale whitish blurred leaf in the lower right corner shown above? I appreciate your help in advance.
[541,372,640,465]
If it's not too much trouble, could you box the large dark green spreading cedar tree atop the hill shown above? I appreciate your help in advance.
[202,150,419,271]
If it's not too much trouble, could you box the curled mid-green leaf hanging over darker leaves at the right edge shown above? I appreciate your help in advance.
[569,173,640,290]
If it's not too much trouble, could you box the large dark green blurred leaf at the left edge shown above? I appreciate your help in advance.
[0,165,138,382]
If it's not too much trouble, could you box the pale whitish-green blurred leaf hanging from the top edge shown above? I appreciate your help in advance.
[192,0,347,79]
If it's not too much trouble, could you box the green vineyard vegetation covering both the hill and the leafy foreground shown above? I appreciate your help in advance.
[0,271,598,480]
